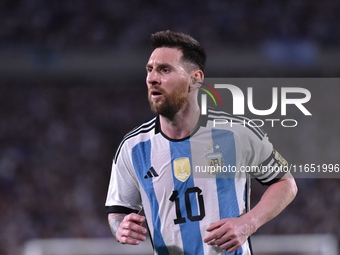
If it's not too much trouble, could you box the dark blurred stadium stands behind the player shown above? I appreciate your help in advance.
[0,0,340,255]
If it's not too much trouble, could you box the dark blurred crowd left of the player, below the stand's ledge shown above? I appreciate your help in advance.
[0,82,151,255]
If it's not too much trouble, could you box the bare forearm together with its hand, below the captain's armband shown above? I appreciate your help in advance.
[204,173,297,253]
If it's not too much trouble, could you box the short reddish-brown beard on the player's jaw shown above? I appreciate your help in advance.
[149,88,187,120]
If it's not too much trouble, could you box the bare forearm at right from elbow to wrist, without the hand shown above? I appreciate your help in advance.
[244,173,297,233]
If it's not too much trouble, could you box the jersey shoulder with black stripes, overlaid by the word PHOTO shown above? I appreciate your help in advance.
[207,106,267,141]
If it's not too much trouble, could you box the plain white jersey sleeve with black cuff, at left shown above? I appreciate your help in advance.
[105,143,142,214]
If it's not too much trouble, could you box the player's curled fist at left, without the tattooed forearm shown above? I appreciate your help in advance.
[116,213,147,245]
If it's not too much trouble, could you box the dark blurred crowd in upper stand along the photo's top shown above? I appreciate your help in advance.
[0,0,340,50]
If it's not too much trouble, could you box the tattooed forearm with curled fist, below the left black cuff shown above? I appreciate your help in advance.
[108,213,147,245]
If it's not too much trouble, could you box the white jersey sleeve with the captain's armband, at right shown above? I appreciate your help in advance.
[243,128,288,186]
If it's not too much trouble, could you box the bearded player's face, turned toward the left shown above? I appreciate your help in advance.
[146,48,190,119]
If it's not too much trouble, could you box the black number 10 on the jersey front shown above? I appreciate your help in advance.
[169,187,205,224]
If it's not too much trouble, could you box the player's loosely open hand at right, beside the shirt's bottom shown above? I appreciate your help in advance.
[203,217,255,253]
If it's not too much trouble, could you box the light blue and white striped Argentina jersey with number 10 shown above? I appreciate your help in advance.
[105,110,286,255]
